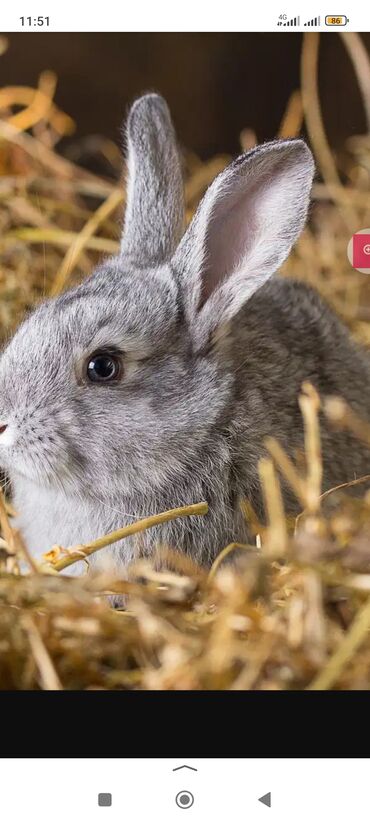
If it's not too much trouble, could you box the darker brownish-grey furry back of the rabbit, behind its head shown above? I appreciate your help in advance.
[232,277,370,511]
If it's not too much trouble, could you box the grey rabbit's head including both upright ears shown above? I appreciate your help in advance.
[0,94,313,506]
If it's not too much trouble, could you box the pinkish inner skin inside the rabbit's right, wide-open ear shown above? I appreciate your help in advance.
[199,180,261,308]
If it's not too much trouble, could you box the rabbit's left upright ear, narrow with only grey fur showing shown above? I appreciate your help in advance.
[121,94,184,266]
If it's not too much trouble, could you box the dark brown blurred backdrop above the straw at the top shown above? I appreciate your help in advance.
[0,33,370,159]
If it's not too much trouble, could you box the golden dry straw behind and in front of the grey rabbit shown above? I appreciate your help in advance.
[0,33,370,690]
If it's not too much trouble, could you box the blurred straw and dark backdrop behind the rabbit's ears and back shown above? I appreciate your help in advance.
[0,32,370,344]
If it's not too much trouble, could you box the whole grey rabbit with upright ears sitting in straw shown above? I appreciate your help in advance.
[0,93,370,574]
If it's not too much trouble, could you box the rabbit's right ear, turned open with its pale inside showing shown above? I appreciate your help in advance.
[173,140,314,347]
